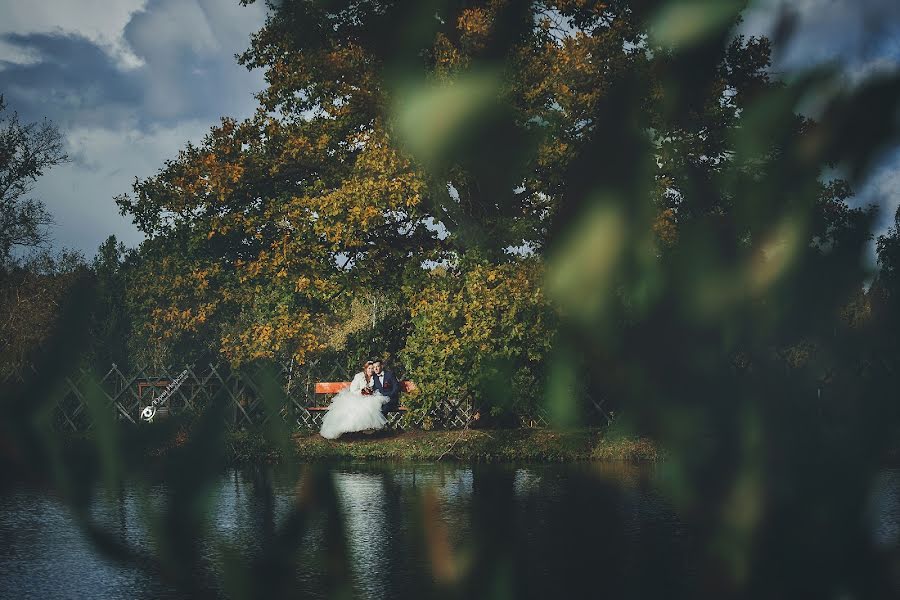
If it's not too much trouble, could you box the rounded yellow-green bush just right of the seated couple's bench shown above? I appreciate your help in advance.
[403,258,557,416]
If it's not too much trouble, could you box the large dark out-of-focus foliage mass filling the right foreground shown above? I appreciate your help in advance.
[243,2,900,597]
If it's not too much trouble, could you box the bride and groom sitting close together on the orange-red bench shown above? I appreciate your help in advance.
[319,360,401,440]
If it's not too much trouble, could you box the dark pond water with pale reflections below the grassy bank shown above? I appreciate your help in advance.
[0,464,900,598]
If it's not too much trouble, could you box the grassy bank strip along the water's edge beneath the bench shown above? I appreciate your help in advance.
[228,429,661,462]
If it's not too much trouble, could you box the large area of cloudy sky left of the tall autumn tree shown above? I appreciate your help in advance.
[0,0,265,257]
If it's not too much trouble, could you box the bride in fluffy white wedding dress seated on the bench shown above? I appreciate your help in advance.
[319,360,390,440]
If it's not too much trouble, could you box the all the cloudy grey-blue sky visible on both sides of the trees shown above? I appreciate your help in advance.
[0,0,900,257]
